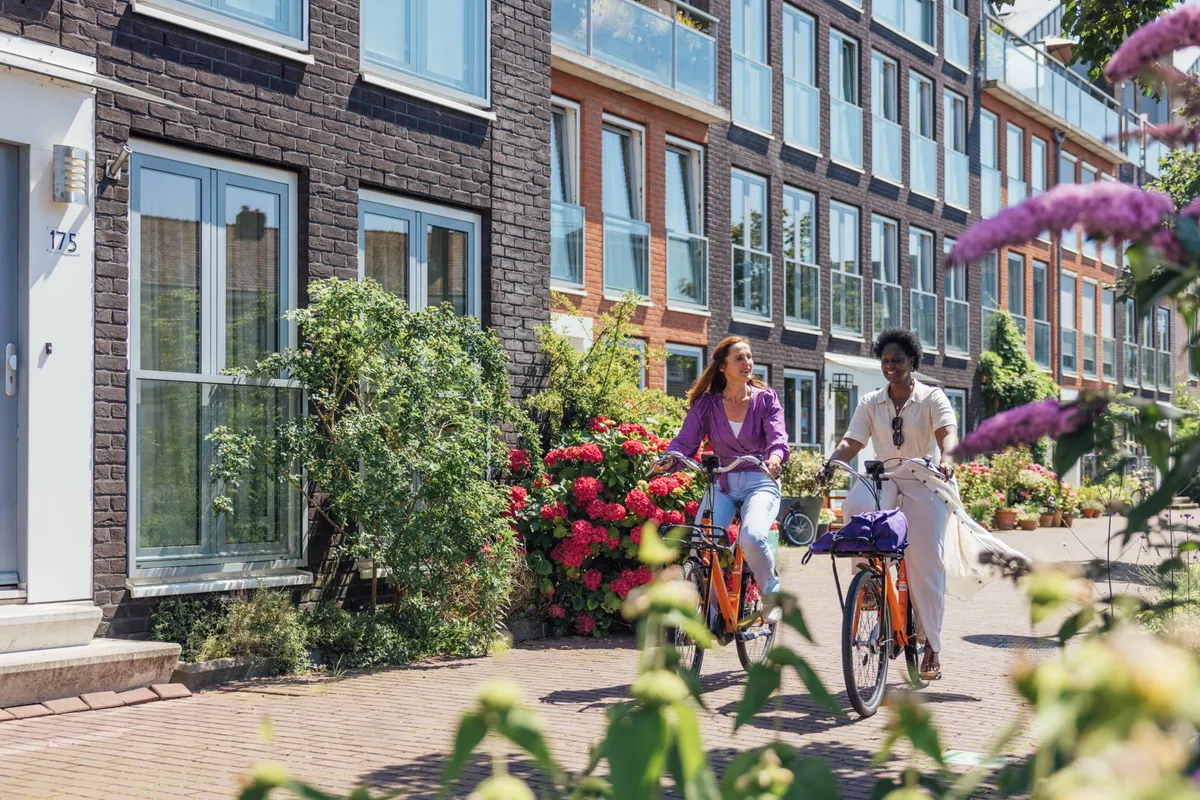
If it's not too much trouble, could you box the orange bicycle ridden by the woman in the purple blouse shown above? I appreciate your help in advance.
[655,451,776,675]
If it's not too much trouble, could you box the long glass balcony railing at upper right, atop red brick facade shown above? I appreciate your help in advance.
[983,20,1121,150]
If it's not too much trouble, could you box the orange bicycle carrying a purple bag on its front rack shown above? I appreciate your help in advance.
[804,458,936,717]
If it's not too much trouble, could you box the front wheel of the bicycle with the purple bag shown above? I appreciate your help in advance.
[841,570,892,717]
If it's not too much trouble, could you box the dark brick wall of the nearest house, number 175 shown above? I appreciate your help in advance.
[0,0,550,636]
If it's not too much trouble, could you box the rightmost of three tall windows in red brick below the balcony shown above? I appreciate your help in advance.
[666,139,708,308]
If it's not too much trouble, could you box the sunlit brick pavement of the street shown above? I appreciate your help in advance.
[0,531,1113,800]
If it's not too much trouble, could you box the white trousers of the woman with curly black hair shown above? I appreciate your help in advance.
[841,477,950,652]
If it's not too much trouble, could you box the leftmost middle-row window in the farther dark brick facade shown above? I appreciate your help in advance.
[730,169,772,320]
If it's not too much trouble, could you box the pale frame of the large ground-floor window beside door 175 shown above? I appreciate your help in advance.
[126,140,308,578]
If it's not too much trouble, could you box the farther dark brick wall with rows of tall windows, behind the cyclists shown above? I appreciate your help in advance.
[708,0,980,441]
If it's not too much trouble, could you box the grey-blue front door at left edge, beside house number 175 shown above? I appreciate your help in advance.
[0,145,23,585]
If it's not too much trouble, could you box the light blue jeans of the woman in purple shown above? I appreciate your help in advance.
[696,470,780,595]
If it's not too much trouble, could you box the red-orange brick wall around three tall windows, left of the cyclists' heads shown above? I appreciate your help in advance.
[551,70,710,389]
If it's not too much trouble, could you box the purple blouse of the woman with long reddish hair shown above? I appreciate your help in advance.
[670,387,791,482]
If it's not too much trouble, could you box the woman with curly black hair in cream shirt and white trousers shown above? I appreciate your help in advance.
[829,327,959,680]
